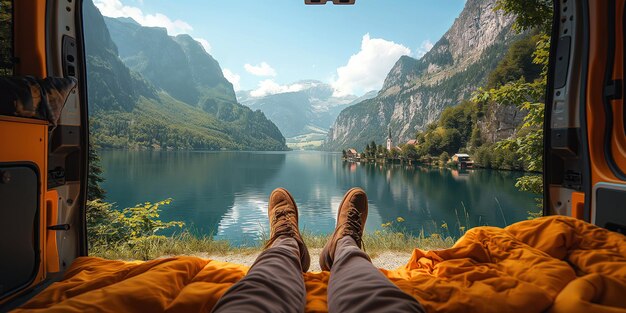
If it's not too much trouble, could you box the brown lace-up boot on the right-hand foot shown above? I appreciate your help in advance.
[320,188,367,271]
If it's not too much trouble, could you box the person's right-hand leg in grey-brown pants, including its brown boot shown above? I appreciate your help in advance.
[320,188,425,312]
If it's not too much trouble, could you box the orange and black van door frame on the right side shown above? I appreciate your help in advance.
[544,0,626,233]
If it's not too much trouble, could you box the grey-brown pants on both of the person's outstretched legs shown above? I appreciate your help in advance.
[213,236,425,312]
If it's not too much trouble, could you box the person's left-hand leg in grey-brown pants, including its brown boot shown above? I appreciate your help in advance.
[213,188,310,312]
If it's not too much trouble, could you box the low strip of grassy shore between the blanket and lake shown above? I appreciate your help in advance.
[89,230,454,260]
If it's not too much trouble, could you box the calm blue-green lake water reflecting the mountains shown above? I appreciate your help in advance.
[101,151,535,244]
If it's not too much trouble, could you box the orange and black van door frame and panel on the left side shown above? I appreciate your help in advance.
[0,0,88,311]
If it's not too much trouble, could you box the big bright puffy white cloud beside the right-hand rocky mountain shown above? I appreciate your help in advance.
[331,34,411,96]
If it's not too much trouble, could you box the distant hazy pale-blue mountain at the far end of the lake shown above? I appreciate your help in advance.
[237,80,374,138]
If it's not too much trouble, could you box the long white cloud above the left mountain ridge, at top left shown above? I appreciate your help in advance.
[94,0,193,34]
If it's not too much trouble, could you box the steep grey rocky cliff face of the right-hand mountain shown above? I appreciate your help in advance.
[324,0,516,150]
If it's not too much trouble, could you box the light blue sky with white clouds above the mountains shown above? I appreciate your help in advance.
[94,0,465,96]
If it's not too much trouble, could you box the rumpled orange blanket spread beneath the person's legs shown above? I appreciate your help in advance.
[17,217,626,313]
